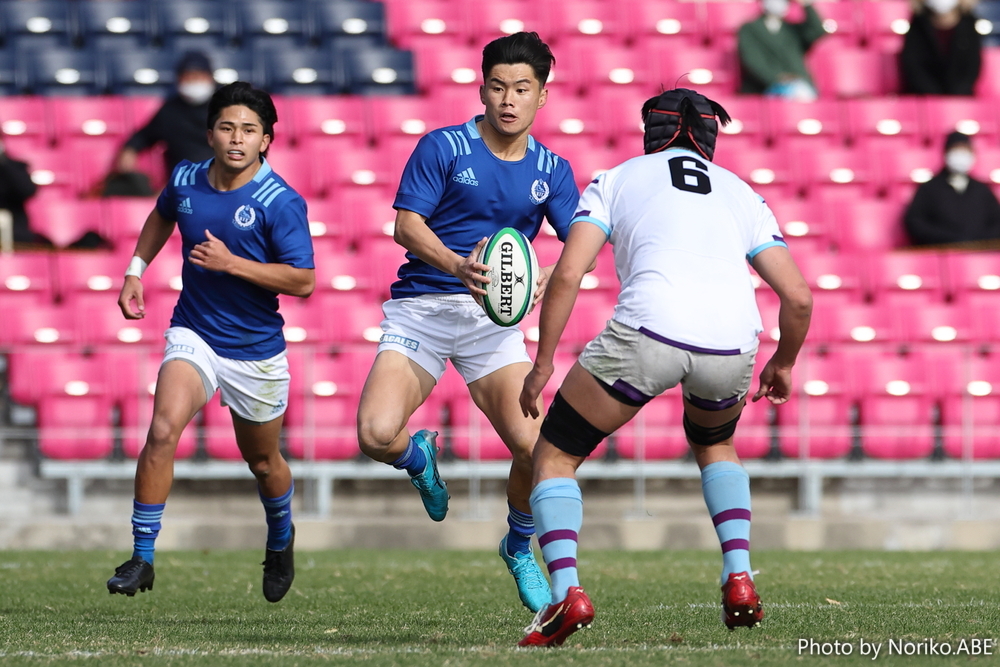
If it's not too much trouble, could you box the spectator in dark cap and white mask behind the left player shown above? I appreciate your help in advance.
[115,51,215,184]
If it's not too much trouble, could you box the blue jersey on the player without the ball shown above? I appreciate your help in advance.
[156,158,314,360]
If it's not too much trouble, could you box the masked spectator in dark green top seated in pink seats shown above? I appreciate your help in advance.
[739,0,826,102]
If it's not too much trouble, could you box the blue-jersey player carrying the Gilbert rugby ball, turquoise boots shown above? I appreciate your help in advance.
[358,32,579,611]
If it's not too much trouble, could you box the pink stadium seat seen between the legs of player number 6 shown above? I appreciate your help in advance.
[614,386,688,461]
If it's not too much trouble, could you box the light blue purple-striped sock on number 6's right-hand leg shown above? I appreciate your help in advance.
[701,461,753,583]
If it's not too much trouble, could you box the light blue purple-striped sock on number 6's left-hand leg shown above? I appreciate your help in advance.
[531,477,583,604]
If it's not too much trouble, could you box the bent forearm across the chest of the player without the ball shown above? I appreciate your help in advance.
[188,229,316,297]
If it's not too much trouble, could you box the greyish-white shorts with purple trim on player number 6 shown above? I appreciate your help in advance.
[580,320,757,410]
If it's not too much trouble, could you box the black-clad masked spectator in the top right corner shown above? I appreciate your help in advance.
[899,0,982,95]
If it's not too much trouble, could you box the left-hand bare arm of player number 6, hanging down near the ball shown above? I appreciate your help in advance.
[520,222,608,418]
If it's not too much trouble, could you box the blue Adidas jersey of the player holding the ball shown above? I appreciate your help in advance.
[392,116,580,299]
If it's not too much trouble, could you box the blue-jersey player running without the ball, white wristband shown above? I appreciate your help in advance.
[108,82,315,602]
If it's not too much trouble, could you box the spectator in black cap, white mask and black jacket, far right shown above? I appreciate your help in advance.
[904,132,1000,245]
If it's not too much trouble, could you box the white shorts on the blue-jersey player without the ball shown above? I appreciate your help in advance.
[161,327,291,423]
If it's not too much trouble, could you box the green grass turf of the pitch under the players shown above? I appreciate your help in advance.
[0,551,1000,667]
